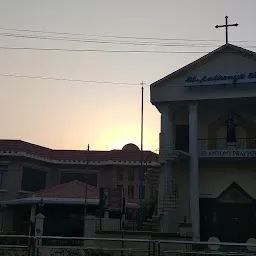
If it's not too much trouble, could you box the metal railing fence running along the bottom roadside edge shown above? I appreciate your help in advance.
[0,235,256,256]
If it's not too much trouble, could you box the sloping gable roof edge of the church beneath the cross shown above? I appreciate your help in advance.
[150,43,256,87]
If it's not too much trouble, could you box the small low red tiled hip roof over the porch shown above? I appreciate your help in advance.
[24,180,99,199]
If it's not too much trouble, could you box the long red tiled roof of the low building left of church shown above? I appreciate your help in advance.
[0,140,158,162]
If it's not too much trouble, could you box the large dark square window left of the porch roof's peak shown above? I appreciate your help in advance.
[21,167,46,192]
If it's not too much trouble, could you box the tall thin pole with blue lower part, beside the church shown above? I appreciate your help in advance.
[140,82,144,225]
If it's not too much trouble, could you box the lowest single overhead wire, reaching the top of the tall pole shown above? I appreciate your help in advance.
[0,73,140,86]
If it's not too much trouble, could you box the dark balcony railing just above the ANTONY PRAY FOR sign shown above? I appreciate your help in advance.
[198,137,256,150]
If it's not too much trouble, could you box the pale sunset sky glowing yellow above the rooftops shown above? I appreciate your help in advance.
[0,0,256,151]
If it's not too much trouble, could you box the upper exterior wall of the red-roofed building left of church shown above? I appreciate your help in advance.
[0,157,156,203]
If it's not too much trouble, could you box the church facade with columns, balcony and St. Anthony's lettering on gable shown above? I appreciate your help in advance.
[151,44,256,242]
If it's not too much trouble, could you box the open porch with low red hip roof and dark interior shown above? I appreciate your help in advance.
[1,181,139,237]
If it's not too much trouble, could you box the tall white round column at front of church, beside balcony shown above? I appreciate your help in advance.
[189,103,200,241]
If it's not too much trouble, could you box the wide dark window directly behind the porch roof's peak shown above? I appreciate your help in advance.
[60,172,98,187]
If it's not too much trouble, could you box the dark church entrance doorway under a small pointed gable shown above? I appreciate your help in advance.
[200,182,256,243]
